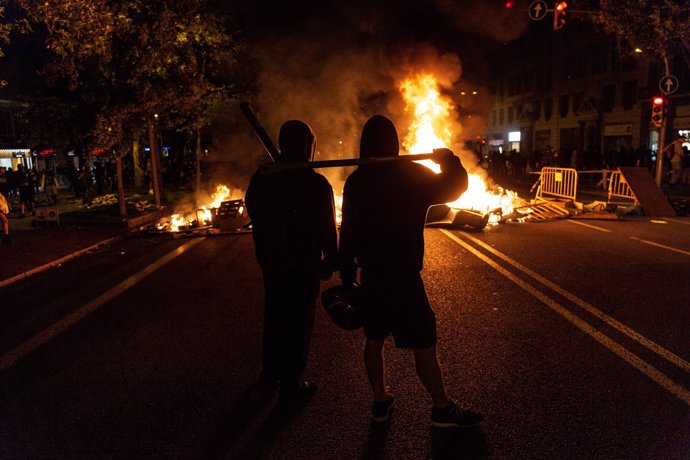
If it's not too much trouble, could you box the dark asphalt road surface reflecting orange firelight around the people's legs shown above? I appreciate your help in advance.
[0,218,690,459]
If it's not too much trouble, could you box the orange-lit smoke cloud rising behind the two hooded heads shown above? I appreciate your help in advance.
[215,0,527,194]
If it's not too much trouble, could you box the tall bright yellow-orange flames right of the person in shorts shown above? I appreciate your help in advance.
[399,74,520,222]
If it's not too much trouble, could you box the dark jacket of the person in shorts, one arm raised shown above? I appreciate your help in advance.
[339,157,467,282]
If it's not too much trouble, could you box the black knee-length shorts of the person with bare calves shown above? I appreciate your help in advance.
[361,268,436,350]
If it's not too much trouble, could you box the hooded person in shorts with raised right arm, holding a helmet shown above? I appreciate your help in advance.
[339,115,482,427]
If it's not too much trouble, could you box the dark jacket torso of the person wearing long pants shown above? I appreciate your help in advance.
[245,169,337,271]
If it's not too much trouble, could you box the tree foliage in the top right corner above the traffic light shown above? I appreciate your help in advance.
[592,0,690,71]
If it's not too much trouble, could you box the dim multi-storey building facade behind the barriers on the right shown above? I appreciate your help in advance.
[486,21,690,169]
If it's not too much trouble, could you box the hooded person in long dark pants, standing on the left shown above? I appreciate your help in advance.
[245,120,338,399]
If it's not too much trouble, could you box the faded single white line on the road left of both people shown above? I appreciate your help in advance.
[0,238,204,372]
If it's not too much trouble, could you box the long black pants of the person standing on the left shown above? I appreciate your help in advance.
[262,269,320,388]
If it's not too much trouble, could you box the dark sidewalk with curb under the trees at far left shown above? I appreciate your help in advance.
[0,191,163,285]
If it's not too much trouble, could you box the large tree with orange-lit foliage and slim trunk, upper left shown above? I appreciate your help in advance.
[16,0,235,212]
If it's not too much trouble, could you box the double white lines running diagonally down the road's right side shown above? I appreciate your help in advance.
[440,229,690,406]
